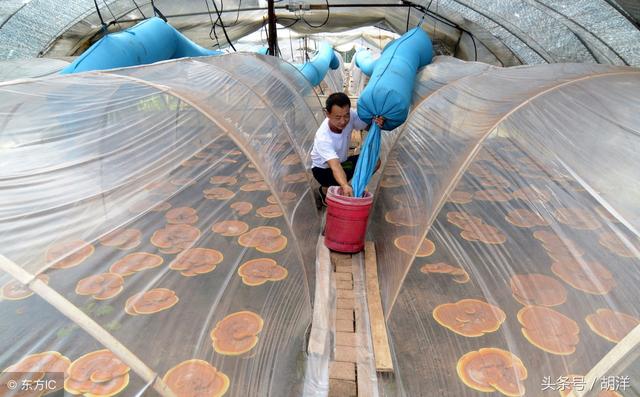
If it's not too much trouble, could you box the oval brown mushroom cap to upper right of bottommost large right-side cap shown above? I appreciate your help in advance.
[518,306,580,355]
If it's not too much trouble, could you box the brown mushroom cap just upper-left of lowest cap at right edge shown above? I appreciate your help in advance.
[551,260,616,295]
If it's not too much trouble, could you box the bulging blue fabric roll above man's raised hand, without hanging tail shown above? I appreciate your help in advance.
[358,27,433,130]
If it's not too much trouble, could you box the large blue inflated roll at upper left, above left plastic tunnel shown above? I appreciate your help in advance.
[60,17,222,74]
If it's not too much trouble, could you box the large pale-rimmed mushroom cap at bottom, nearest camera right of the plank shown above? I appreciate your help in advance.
[456,347,527,397]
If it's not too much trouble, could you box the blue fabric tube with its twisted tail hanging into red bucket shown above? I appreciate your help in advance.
[352,27,433,197]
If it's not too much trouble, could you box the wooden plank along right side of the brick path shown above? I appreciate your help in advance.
[364,241,393,372]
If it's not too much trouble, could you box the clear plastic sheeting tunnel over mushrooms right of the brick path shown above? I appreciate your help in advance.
[370,65,640,396]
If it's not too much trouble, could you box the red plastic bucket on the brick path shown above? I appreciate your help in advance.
[324,186,373,253]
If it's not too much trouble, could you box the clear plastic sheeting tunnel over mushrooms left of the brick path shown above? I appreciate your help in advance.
[0,54,321,396]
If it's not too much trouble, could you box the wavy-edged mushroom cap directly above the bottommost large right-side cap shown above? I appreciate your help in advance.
[433,299,507,337]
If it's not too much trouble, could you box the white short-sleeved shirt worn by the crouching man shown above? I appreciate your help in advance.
[311,109,367,168]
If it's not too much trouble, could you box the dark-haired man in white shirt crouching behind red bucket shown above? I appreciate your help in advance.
[311,92,384,204]
